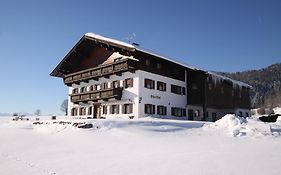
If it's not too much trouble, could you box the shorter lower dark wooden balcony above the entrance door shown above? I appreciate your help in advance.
[70,87,123,103]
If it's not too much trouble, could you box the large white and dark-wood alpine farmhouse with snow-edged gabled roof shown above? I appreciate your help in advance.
[50,33,251,121]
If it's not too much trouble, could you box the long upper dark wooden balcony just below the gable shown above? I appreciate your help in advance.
[64,58,137,86]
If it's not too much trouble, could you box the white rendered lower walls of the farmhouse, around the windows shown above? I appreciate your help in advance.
[68,70,187,118]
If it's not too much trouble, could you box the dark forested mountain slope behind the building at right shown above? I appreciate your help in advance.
[219,63,281,107]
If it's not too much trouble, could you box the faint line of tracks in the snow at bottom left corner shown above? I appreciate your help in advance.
[0,153,58,175]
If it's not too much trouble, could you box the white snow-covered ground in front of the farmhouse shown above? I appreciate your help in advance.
[0,115,281,175]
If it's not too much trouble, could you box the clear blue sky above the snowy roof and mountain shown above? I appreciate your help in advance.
[0,0,281,114]
